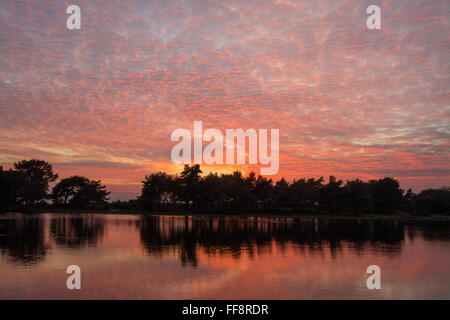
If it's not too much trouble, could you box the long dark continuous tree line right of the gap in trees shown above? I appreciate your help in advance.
[139,165,450,215]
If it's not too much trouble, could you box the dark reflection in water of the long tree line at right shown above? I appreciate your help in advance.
[140,216,449,266]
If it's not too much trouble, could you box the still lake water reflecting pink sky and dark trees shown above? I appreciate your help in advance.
[0,214,450,299]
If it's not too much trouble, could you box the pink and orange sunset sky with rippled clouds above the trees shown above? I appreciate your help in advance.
[0,0,450,199]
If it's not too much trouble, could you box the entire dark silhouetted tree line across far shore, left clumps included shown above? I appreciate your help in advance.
[0,159,450,215]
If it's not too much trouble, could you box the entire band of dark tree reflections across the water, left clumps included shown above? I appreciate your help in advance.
[0,214,450,266]
